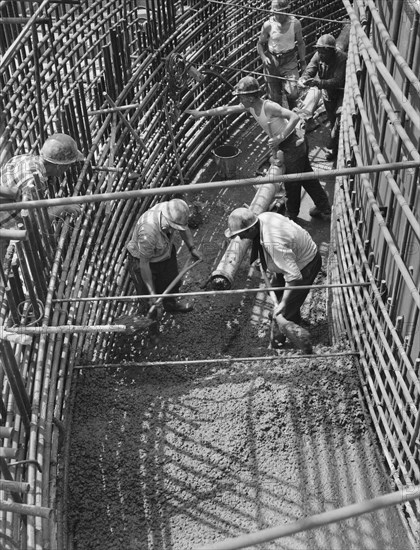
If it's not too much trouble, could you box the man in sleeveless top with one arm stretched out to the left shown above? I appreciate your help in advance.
[187,76,331,221]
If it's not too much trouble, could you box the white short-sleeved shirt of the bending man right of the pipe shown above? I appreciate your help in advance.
[258,212,318,283]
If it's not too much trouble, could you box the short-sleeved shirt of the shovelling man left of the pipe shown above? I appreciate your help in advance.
[127,203,175,263]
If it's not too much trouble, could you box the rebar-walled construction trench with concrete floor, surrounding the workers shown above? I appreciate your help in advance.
[0,0,420,550]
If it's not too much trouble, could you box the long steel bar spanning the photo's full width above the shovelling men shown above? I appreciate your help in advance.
[0,161,420,212]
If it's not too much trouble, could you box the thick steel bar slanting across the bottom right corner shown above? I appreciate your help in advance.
[194,485,420,550]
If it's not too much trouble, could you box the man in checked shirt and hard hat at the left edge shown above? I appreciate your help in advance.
[0,134,84,233]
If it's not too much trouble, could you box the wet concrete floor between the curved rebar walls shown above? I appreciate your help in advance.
[67,120,412,550]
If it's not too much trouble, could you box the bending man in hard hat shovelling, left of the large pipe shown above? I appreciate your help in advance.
[127,199,201,313]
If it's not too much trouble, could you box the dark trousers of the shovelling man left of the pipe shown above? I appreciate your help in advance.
[128,246,181,309]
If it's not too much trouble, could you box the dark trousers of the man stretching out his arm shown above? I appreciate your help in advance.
[279,136,331,218]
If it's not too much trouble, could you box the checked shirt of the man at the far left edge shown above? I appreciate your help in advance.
[0,155,47,229]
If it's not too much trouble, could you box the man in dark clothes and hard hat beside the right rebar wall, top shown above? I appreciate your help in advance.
[298,34,347,161]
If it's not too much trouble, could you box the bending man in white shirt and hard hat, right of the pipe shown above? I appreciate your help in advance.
[225,207,322,348]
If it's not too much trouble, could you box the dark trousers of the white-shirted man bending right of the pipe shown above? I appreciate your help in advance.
[272,252,322,323]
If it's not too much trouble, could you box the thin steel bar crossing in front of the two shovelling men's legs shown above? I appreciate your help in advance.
[51,283,371,306]
